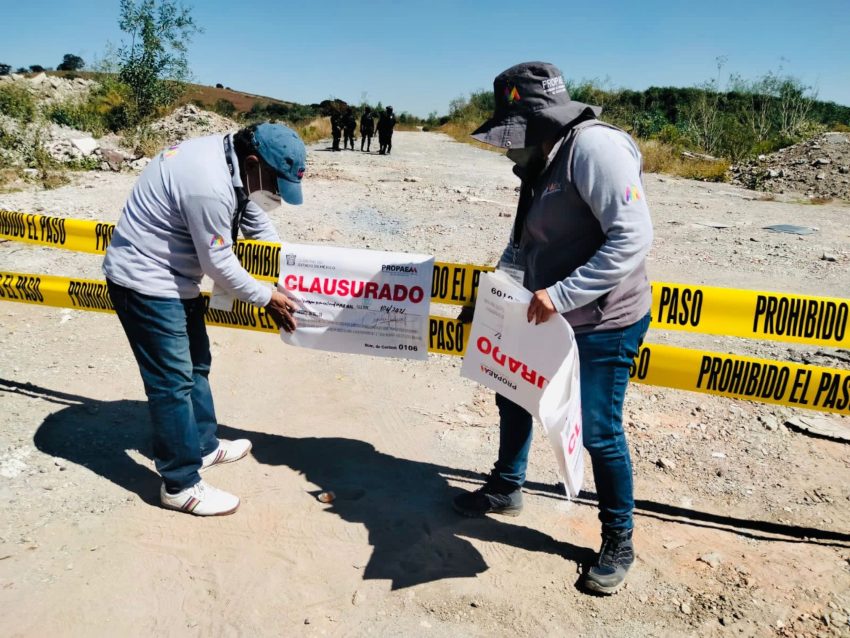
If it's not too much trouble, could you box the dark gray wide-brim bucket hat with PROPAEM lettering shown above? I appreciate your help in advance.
[472,62,602,148]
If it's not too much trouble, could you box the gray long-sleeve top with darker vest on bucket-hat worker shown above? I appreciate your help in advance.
[503,121,653,328]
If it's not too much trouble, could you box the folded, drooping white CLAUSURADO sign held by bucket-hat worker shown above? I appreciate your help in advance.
[460,271,584,498]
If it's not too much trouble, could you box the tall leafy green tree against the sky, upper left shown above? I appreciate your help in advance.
[118,0,202,119]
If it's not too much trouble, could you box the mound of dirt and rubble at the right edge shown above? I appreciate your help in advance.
[732,132,850,199]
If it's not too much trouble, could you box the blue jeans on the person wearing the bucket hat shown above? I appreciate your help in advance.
[493,315,649,532]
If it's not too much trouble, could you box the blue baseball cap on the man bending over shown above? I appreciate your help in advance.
[254,122,307,206]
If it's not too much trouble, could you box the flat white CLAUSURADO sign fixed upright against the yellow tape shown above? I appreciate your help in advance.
[278,243,434,359]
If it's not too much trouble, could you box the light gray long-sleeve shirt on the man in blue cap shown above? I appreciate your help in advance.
[103,135,280,306]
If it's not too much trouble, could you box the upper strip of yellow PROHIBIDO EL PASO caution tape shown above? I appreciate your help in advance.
[0,210,850,346]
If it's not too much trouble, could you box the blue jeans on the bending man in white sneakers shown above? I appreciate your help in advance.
[107,280,218,491]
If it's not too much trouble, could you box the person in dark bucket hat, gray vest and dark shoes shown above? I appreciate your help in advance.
[454,62,652,594]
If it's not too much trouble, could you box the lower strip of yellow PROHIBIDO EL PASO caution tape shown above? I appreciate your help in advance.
[0,272,850,416]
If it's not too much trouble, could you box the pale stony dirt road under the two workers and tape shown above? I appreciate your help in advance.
[0,133,850,636]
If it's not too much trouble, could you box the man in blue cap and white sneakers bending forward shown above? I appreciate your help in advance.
[103,123,306,516]
